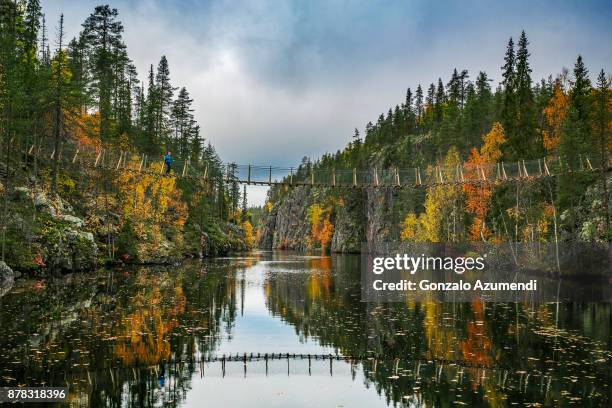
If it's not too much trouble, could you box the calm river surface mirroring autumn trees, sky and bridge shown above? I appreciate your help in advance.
[0,252,612,407]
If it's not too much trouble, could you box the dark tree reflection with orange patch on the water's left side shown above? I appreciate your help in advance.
[0,265,236,407]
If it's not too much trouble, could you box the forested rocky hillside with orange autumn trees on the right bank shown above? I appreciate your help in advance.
[260,32,612,252]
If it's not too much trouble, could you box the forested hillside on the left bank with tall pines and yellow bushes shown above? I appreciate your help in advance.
[0,0,252,270]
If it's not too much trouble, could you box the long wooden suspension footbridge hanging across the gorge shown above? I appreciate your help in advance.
[9,138,612,188]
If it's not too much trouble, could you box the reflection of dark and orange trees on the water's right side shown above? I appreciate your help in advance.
[264,257,611,406]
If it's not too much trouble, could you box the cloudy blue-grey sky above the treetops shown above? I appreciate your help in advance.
[42,0,612,203]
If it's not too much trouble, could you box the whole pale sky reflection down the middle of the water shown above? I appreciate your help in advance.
[184,256,387,408]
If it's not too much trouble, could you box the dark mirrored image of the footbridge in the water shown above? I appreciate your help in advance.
[62,353,553,393]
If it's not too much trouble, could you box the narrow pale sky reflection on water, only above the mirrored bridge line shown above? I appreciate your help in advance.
[210,257,334,355]
